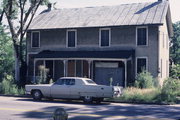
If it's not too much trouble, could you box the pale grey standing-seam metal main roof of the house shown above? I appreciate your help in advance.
[29,1,169,30]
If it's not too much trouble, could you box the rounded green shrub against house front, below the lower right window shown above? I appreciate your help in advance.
[135,70,154,88]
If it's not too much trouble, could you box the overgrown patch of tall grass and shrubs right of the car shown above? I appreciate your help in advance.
[107,71,180,104]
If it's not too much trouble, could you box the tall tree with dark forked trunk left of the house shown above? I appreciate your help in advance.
[1,0,49,86]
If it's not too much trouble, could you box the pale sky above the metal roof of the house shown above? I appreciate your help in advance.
[37,0,180,23]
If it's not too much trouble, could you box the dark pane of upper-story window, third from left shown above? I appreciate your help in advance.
[101,30,109,46]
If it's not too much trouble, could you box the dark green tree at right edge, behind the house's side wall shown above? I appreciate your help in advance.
[170,22,180,64]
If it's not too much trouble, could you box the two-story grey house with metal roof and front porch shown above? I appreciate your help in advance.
[27,0,173,87]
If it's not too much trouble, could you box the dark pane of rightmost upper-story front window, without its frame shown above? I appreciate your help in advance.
[137,28,147,45]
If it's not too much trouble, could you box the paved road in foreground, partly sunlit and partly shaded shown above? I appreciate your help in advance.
[0,96,180,120]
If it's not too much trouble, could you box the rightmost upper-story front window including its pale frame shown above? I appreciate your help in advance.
[136,27,148,45]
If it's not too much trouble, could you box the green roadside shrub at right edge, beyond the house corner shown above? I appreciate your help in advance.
[160,78,180,103]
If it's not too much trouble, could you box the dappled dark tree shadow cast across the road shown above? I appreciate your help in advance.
[15,99,180,120]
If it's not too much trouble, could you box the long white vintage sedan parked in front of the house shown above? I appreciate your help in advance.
[25,77,121,103]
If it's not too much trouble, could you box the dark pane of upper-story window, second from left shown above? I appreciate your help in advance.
[68,31,76,47]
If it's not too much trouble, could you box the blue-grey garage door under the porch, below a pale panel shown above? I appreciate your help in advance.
[95,68,124,86]
